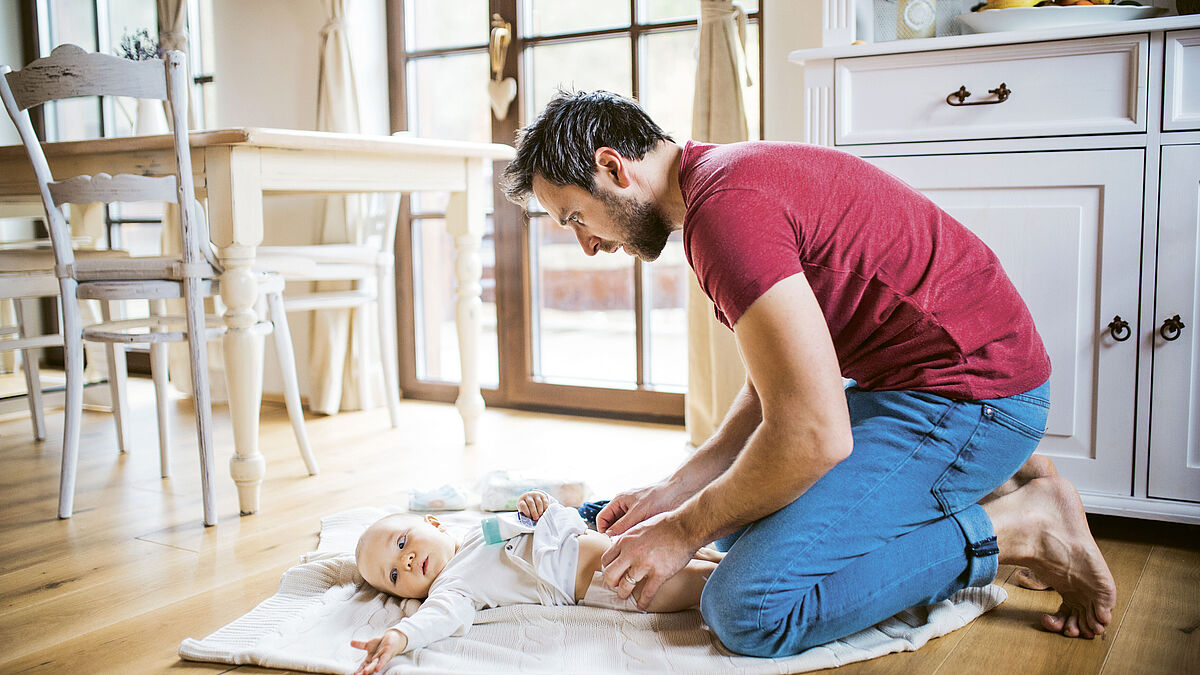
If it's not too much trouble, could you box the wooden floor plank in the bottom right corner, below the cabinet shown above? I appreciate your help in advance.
[1102,545,1200,675]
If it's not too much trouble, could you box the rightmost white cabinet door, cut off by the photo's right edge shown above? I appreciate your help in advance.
[1147,145,1200,502]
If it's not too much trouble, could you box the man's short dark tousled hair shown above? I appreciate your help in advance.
[500,90,671,205]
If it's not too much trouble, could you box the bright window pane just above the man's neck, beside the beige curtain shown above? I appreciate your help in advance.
[638,30,698,143]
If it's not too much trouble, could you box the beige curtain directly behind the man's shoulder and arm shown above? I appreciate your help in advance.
[684,0,749,447]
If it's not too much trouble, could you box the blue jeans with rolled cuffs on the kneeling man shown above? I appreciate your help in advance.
[700,384,1050,656]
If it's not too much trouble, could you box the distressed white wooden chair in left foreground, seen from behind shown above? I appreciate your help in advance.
[0,44,317,525]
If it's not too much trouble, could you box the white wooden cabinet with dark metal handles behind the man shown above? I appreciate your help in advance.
[787,16,1200,524]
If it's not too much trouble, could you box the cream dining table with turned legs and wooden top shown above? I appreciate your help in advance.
[0,127,514,515]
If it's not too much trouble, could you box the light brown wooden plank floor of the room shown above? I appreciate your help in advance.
[0,380,1200,675]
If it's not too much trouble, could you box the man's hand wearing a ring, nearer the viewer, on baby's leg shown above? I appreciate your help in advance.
[600,513,701,611]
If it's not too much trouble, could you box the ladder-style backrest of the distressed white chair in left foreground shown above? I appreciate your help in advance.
[0,44,208,269]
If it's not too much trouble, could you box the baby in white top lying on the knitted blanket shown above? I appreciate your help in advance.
[350,490,721,675]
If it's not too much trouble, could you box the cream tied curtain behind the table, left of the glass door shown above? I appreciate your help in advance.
[308,0,385,414]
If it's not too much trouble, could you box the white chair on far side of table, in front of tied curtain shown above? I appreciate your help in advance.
[254,187,400,429]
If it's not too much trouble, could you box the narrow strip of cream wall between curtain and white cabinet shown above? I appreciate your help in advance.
[761,0,822,139]
